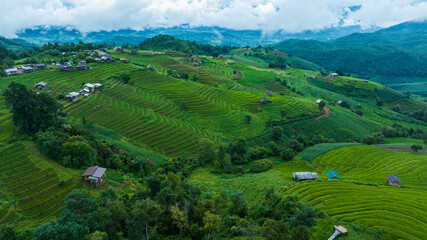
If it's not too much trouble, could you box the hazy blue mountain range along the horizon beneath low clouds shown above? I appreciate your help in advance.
[10,25,377,47]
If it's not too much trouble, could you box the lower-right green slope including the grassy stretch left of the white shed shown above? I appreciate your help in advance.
[190,144,427,239]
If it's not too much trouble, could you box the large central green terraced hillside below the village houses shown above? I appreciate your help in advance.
[0,59,317,156]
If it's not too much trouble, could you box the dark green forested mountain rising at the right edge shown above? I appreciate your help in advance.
[275,21,427,78]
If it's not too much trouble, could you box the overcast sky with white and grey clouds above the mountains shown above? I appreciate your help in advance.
[0,0,427,37]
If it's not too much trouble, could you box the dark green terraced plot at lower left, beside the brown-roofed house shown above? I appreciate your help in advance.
[0,143,79,223]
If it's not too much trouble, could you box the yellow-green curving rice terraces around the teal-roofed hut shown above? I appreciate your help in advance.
[290,146,427,239]
